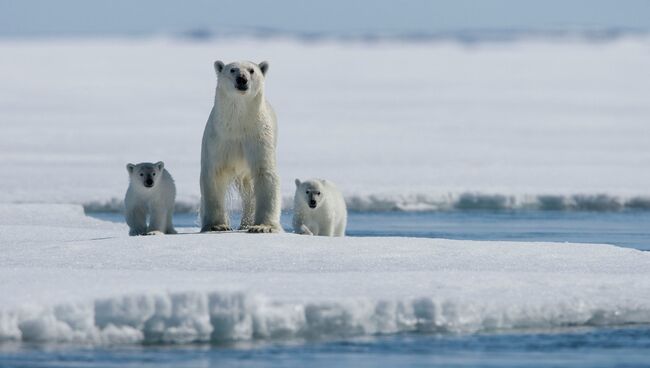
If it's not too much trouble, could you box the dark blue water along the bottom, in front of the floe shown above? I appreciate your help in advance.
[0,326,650,368]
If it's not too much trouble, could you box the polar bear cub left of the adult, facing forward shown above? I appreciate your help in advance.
[124,161,176,236]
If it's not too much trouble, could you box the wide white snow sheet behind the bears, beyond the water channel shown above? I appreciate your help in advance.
[0,37,650,211]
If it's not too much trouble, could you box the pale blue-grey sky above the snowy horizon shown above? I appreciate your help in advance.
[0,0,650,36]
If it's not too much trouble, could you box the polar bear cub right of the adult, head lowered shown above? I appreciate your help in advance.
[293,179,348,236]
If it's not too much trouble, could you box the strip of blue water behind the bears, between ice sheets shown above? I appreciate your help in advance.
[90,211,650,250]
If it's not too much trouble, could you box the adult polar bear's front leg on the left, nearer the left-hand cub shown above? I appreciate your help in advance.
[201,169,232,232]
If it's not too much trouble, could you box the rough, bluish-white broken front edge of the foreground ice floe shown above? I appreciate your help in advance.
[0,292,650,344]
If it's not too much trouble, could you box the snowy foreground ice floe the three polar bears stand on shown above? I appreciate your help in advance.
[0,205,650,344]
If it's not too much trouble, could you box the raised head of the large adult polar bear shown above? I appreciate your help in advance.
[214,60,269,96]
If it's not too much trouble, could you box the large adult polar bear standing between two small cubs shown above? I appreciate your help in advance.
[201,61,282,233]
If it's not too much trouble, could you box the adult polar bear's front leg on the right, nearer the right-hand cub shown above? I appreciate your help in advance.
[248,169,282,233]
